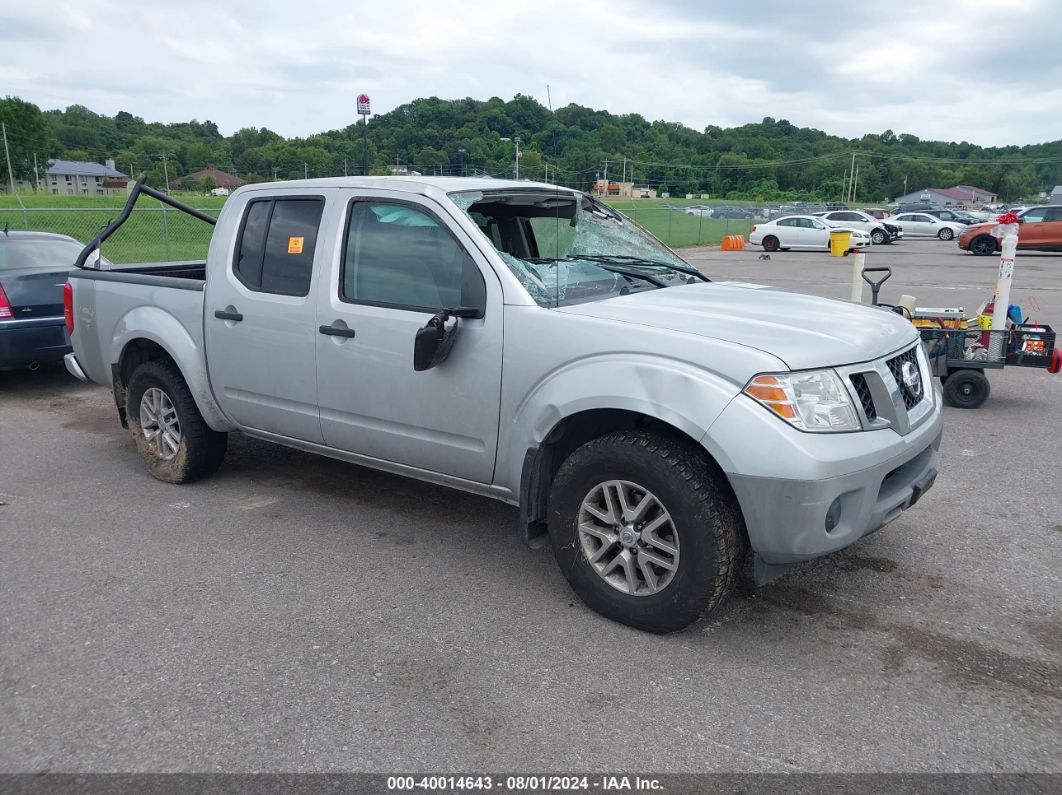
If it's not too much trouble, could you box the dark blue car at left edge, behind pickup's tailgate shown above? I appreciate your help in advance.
[0,230,103,369]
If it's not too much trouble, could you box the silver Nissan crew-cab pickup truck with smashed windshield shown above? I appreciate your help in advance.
[65,177,942,632]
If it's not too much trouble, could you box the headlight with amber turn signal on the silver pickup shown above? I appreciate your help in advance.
[744,369,859,433]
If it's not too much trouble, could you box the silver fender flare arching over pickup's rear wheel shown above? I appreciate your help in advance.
[110,306,236,431]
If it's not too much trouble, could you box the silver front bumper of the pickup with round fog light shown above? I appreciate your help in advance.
[708,379,943,566]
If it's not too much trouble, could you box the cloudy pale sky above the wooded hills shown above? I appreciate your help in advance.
[0,0,1062,145]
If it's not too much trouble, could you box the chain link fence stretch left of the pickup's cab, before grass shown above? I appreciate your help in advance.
[0,202,220,264]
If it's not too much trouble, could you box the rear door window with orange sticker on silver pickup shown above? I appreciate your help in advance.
[233,196,325,297]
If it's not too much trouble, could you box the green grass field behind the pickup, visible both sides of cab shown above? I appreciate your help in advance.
[0,193,753,258]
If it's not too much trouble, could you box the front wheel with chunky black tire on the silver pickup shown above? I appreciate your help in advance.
[548,430,748,633]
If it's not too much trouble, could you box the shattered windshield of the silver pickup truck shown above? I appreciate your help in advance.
[450,188,707,307]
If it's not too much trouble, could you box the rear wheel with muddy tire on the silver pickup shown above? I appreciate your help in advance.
[125,359,228,483]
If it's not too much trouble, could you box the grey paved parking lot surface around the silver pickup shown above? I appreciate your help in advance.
[0,241,1062,773]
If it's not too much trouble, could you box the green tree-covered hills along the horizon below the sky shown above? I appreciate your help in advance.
[0,94,1062,203]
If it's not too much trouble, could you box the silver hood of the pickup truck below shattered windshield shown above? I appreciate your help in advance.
[555,281,919,369]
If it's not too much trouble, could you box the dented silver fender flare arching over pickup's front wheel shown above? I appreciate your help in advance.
[496,353,741,494]
